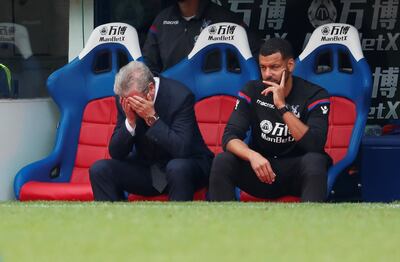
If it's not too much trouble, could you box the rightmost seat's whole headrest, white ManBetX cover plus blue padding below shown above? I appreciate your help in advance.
[293,23,371,101]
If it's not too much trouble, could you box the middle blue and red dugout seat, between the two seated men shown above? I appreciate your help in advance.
[129,23,260,200]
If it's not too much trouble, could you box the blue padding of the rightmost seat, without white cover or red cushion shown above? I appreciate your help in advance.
[294,44,372,192]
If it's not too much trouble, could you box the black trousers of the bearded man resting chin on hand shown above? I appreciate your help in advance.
[209,152,331,202]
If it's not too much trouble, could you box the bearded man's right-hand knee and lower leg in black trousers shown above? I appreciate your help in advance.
[299,152,331,202]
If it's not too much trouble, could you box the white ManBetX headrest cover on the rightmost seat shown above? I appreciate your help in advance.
[299,23,364,62]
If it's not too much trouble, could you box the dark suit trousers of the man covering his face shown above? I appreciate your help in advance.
[89,159,212,201]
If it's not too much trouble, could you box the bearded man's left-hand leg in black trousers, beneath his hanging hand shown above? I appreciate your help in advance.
[210,152,287,201]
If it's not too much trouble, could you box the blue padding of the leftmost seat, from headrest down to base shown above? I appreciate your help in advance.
[14,43,142,199]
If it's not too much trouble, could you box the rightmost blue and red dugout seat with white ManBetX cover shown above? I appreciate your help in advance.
[241,23,372,201]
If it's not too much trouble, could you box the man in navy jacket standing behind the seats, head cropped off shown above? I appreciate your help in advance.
[143,0,260,73]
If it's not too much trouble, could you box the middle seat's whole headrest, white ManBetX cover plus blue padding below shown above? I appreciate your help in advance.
[162,23,260,100]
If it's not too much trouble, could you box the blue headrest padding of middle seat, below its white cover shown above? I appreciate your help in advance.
[162,43,260,101]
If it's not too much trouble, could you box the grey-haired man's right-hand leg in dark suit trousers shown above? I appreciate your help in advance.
[165,159,211,201]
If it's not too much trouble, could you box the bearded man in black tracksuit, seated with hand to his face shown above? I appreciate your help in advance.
[210,38,331,202]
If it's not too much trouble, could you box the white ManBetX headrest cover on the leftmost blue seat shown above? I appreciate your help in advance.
[79,23,142,60]
